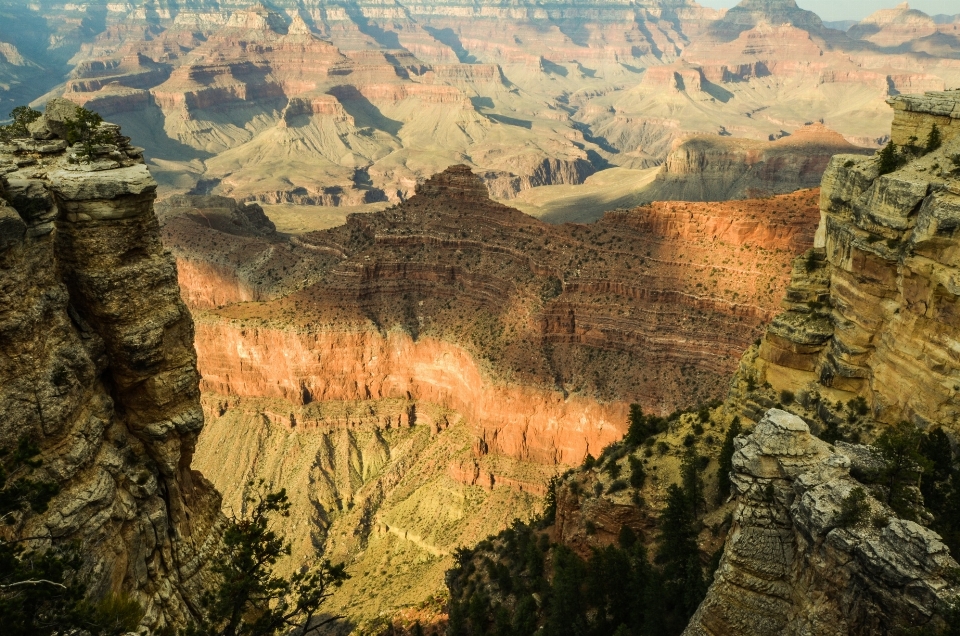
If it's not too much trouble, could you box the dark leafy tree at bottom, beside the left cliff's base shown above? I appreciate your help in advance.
[184,483,349,636]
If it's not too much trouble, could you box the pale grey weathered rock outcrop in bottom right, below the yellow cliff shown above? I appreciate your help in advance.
[684,409,958,636]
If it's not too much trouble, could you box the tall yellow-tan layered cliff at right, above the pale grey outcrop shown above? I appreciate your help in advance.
[755,92,960,430]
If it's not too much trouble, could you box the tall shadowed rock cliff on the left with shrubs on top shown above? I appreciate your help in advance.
[0,100,220,627]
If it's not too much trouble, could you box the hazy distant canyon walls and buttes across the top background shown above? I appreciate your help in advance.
[0,0,960,206]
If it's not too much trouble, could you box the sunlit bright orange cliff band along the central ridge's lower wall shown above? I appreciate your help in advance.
[197,319,628,464]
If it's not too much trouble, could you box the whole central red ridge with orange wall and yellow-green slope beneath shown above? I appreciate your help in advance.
[158,161,819,626]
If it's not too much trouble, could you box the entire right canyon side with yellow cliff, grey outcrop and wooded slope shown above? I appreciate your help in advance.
[448,91,960,636]
